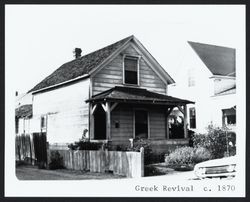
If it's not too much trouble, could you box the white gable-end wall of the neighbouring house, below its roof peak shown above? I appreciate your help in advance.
[168,43,214,132]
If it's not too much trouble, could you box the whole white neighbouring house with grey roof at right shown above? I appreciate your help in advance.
[169,41,236,132]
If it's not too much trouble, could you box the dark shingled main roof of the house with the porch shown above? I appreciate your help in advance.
[29,35,174,92]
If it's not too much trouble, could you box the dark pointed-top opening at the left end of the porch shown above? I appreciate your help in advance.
[94,105,106,140]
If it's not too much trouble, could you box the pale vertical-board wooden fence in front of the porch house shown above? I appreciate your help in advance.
[50,148,144,177]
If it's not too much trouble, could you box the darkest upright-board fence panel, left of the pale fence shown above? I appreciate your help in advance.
[33,132,47,168]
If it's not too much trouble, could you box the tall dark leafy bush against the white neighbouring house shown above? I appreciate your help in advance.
[192,125,236,159]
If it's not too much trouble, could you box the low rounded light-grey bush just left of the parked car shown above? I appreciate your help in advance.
[165,147,211,169]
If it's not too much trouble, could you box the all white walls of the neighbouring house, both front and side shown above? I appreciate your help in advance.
[169,43,236,133]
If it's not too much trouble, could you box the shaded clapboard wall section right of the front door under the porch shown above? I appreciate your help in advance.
[149,110,166,139]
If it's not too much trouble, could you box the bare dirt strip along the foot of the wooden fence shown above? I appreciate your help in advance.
[16,166,124,180]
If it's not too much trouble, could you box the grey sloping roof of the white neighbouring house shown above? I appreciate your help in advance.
[188,41,235,77]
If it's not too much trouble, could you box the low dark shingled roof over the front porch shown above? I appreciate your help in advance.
[86,86,194,105]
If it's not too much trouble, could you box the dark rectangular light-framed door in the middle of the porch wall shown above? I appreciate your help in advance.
[135,110,148,138]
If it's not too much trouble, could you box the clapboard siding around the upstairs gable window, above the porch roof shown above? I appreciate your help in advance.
[92,43,166,95]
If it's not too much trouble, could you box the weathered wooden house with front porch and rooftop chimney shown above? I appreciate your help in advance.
[23,36,192,151]
